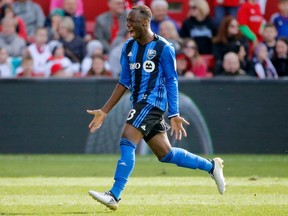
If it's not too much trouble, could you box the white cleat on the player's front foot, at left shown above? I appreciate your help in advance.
[88,190,119,211]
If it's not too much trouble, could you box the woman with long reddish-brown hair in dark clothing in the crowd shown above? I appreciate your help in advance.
[213,16,249,75]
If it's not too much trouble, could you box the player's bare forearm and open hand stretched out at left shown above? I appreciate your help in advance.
[87,83,127,133]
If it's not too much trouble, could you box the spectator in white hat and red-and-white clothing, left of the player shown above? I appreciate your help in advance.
[47,41,75,75]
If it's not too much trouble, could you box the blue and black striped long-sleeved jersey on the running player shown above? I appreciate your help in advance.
[119,35,179,117]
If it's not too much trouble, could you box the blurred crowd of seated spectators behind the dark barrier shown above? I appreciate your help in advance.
[0,0,288,79]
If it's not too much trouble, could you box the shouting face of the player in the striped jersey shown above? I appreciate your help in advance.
[127,11,145,40]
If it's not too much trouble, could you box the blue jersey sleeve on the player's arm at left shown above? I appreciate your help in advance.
[119,43,131,89]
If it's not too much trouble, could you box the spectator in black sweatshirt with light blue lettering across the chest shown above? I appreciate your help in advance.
[180,0,216,54]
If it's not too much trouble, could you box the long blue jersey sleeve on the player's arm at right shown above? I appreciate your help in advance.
[161,45,179,118]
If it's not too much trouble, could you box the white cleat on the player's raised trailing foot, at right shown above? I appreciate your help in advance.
[210,158,226,194]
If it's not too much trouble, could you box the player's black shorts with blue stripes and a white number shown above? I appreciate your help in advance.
[126,103,170,142]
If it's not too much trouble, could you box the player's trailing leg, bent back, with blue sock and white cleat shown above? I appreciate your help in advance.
[145,131,226,194]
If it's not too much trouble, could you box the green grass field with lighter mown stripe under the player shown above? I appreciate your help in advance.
[0,155,288,216]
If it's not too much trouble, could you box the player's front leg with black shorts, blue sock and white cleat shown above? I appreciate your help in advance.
[89,104,158,210]
